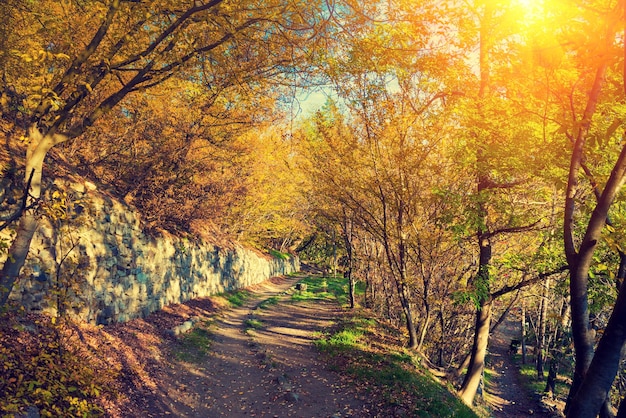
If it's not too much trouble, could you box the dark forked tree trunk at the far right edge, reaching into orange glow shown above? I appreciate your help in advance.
[564,2,626,416]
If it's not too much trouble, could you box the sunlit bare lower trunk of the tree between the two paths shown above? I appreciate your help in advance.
[459,299,491,406]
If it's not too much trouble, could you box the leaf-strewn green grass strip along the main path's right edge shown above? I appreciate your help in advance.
[316,312,477,418]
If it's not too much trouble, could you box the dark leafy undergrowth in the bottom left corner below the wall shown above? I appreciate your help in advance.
[0,313,115,417]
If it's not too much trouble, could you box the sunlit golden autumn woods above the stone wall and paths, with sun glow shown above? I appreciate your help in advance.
[0,0,626,417]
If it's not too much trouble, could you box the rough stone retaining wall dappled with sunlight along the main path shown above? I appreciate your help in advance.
[3,183,300,324]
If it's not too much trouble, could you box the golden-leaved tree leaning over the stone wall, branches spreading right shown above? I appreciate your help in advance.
[0,0,325,304]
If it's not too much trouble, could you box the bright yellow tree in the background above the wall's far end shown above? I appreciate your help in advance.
[222,122,314,248]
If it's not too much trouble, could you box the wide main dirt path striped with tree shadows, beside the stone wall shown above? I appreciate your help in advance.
[141,278,372,417]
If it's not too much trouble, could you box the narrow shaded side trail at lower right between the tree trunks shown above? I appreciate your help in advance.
[485,313,553,418]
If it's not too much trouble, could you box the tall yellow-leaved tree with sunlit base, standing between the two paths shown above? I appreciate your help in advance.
[404,1,564,404]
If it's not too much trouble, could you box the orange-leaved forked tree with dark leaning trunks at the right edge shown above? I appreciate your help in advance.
[564,2,626,417]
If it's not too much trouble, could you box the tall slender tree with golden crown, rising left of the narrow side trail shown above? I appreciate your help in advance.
[459,1,556,404]
